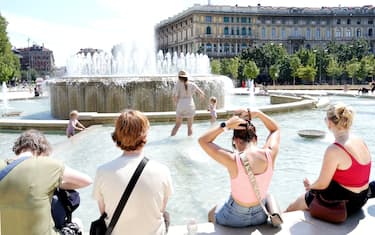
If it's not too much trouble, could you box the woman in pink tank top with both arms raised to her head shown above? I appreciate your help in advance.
[199,109,280,227]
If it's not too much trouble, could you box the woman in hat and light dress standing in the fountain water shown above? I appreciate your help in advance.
[171,70,205,136]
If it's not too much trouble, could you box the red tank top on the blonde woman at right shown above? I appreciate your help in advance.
[333,143,371,187]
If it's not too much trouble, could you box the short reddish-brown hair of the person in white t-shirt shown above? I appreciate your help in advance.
[112,110,150,151]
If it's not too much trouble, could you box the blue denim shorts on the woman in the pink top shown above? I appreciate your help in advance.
[215,196,267,228]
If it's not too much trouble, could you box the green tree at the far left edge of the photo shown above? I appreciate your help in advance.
[0,15,20,82]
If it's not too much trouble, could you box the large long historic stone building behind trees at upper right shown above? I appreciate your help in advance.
[155,4,375,58]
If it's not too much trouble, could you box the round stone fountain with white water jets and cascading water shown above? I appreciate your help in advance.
[48,48,233,119]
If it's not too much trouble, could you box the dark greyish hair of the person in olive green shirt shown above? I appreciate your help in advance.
[13,129,52,156]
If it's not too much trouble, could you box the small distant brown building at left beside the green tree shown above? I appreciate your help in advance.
[17,45,55,75]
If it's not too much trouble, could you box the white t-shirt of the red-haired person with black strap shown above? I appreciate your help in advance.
[93,154,173,235]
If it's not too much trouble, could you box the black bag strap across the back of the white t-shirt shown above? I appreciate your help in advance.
[105,157,148,235]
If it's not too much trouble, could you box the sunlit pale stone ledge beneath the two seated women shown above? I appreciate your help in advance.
[168,199,375,235]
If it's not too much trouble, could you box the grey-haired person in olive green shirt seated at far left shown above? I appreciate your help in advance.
[0,130,92,235]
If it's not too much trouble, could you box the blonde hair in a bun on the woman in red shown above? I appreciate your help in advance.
[327,103,354,129]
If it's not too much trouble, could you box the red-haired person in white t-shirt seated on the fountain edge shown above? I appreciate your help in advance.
[93,110,173,235]
